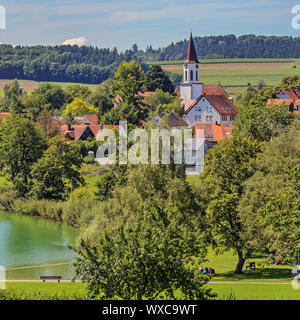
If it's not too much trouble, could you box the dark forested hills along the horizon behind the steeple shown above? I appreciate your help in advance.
[0,35,300,84]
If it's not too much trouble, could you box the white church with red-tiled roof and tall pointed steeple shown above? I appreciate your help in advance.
[180,34,237,126]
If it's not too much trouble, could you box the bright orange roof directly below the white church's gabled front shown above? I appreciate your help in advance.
[194,123,232,142]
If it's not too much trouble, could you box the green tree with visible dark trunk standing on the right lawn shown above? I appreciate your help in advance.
[201,137,261,273]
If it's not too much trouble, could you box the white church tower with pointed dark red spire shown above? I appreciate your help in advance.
[180,33,203,100]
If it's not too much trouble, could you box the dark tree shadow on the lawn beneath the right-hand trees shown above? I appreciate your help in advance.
[216,266,292,281]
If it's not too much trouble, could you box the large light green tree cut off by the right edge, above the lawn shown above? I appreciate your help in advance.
[239,122,300,262]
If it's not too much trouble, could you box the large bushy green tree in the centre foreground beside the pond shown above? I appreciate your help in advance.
[76,165,212,300]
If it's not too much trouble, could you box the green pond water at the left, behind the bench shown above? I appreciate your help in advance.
[0,213,76,279]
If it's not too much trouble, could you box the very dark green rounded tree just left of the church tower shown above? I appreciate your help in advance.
[145,65,174,93]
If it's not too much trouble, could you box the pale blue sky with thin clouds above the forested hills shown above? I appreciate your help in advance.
[0,0,300,50]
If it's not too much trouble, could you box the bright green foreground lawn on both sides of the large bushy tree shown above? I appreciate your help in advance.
[1,250,300,300]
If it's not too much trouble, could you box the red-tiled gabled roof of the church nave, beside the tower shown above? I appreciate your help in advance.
[185,94,238,115]
